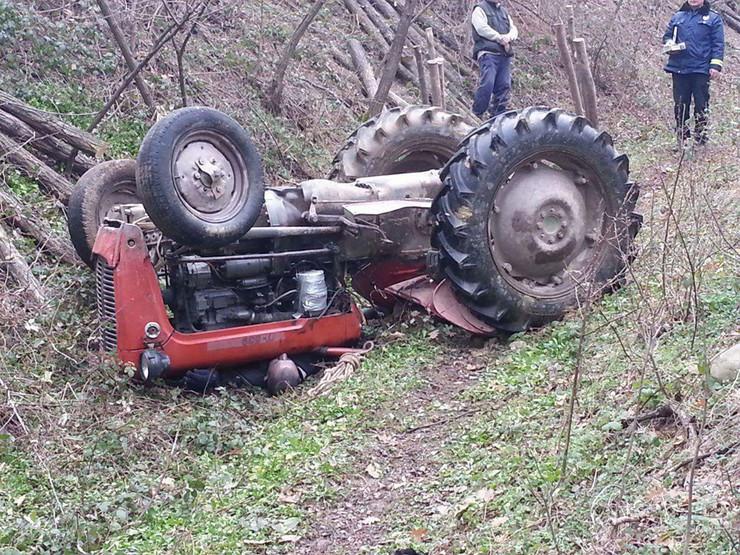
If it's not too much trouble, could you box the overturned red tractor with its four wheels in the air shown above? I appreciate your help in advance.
[69,106,639,388]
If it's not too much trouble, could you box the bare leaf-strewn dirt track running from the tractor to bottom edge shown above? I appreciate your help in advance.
[295,340,499,555]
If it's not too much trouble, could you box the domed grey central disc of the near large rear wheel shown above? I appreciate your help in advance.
[489,164,588,285]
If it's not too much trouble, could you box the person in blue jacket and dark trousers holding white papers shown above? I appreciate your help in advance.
[663,0,725,146]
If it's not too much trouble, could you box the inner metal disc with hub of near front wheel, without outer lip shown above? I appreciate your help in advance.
[175,141,235,214]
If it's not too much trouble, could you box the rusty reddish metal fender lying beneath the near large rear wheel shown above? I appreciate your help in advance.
[385,276,496,335]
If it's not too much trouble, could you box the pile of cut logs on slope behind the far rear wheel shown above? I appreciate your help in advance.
[342,0,474,120]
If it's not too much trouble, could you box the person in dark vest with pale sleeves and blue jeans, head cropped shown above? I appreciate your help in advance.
[471,0,519,117]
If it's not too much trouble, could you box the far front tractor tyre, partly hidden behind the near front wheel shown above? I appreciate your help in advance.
[67,160,141,268]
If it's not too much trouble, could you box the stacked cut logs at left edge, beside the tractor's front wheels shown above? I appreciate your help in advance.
[0,91,106,303]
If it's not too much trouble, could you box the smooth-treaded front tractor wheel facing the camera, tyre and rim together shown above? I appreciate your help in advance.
[136,107,264,249]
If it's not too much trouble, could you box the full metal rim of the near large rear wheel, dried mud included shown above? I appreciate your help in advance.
[488,153,607,298]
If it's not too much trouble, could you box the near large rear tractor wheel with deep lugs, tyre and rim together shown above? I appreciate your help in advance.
[432,108,640,332]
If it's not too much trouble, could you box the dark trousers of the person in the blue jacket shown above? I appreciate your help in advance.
[673,73,709,144]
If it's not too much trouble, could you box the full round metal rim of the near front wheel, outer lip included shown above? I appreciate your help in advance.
[172,131,249,223]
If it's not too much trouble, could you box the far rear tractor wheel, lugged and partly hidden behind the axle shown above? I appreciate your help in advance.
[329,106,473,181]
